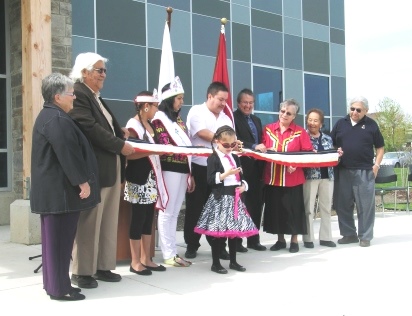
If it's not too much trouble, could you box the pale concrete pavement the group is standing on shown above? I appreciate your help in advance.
[0,212,412,316]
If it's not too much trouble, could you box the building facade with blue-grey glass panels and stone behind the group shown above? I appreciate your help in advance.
[0,0,346,224]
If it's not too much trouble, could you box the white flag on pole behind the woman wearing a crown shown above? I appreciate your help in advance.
[157,21,175,102]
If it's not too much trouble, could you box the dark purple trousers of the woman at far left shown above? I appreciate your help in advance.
[40,212,80,296]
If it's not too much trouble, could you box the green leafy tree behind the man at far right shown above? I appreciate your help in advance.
[375,97,412,151]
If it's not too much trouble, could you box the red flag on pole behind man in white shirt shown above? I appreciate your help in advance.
[212,24,234,122]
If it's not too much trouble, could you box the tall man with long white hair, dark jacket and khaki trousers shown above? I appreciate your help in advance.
[69,53,134,288]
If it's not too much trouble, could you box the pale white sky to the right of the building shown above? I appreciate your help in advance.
[345,0,412,115]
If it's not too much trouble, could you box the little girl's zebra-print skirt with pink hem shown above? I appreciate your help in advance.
[195,193,259,238]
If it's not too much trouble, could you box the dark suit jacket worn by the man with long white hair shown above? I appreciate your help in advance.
[69,82,126,187]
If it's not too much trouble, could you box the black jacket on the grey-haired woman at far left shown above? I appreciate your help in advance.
[30,103,100,214]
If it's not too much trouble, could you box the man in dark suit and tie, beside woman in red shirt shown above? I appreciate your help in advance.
[234,89,266,252]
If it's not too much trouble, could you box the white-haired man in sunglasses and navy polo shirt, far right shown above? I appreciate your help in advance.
[331,97,385,247]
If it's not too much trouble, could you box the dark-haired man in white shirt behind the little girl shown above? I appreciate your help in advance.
[184,81,234,260]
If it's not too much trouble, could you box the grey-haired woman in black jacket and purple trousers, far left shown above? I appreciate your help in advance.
[30,73,100,301]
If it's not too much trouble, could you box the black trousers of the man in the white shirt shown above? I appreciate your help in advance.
[183,163,226,251]
